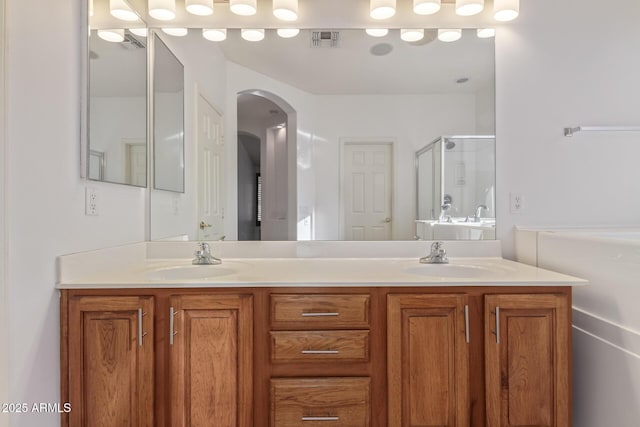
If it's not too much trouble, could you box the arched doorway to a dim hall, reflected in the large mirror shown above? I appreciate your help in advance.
[237,90,297,240]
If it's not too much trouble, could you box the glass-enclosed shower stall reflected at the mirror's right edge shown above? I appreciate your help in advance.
[416,135,496,240]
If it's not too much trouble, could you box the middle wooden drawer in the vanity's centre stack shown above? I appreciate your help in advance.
[271,331,369,363]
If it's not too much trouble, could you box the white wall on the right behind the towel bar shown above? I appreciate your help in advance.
[496,0,640,257]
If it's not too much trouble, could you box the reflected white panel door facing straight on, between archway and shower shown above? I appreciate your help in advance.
[342,143,393,240]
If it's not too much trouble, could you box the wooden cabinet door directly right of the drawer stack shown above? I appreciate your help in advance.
[387,295,469,427]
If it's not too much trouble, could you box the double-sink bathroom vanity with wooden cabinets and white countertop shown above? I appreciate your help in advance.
[58,243,584,427]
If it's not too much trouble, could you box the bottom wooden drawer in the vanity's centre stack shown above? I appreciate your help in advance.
[271,378,371,427]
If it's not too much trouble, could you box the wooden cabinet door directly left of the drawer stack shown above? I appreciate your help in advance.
[169,295,253,427]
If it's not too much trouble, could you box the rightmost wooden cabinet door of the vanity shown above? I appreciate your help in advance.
[485,294,571,427]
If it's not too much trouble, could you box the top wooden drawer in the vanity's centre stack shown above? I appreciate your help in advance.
[271,294,371,329]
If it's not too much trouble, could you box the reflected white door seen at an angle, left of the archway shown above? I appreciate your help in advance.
[196,96,225,240]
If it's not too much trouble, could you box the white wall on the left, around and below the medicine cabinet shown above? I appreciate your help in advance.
[5,0,146,427]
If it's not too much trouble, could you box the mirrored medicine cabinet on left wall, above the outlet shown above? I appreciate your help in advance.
[84,0,147,187]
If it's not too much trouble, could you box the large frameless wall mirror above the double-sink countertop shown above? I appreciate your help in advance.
[150,28,495,240]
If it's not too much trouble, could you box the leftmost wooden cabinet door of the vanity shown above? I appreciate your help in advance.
[69,296,153,427]
